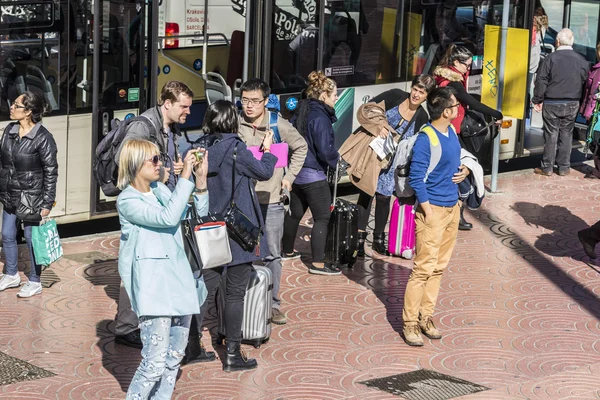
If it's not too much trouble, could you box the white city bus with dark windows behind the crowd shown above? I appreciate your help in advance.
[0,0,600,222]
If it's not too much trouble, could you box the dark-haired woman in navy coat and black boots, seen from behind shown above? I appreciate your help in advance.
[189,100,277,372]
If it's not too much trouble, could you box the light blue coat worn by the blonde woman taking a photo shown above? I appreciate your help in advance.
[117,178,208,316]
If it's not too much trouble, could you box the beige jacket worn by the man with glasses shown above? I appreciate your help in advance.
[239,112,308,204]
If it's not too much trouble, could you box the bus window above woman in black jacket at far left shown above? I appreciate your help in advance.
[0,1,68,120]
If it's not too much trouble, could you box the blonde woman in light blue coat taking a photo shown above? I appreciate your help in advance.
[117,140,208,400]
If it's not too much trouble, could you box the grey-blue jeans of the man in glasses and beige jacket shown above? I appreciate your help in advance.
[260,203,285,309]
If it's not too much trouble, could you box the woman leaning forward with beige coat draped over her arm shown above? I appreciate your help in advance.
[357,75,435,257]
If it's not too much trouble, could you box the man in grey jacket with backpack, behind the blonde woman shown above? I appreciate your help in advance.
[115,81,194,349]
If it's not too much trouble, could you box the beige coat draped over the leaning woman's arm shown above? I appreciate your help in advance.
[339,101,400,196]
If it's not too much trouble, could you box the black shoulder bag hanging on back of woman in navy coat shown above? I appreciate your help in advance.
[223,143,262,253]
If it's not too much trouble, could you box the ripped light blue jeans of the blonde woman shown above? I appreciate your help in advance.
[126,315,191,400]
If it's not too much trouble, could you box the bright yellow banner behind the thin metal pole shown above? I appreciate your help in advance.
[481,25,529,119]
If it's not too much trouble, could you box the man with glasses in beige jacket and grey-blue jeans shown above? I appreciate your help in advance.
[239,79,308,325]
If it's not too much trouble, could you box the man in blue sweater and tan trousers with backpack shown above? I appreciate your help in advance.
[402,87,469,346]
